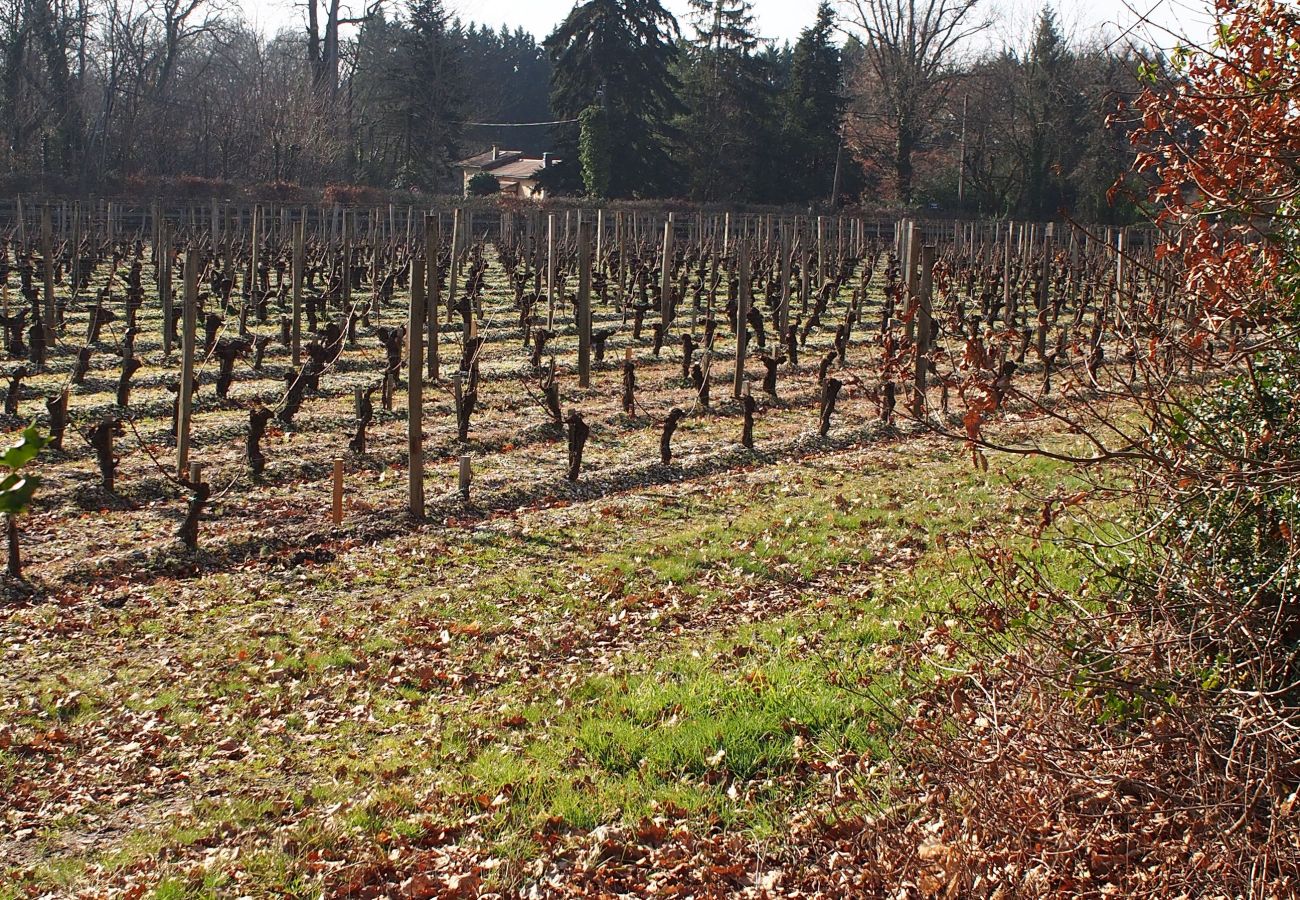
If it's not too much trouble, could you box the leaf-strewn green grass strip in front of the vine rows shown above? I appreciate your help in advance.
[0,408,1107,897]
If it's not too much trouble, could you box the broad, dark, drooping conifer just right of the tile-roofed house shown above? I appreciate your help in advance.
[543,0,683,198]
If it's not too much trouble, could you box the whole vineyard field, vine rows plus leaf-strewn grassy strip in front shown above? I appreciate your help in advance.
[0,204,1180,896]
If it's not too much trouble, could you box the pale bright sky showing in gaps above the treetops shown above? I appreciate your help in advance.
[243,0,1210,47]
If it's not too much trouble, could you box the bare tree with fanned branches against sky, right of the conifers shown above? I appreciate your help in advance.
[846,0,988,203]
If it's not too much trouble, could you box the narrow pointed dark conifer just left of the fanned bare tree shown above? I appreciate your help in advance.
[783,0,844,202]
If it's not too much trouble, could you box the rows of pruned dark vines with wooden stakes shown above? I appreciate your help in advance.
[4,205,1161,580]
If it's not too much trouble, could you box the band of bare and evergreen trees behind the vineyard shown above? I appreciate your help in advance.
[0,0,1162,222]
